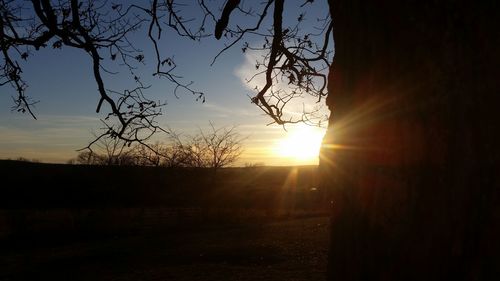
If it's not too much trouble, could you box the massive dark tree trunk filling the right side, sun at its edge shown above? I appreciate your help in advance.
[320,0,500,280]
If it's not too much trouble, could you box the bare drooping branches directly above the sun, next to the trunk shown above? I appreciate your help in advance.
[204,0,333,125]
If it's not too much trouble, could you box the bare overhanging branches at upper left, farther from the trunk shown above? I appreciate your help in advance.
[0,0,204,147]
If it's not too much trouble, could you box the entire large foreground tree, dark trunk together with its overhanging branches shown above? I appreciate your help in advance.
[0,0,500,280]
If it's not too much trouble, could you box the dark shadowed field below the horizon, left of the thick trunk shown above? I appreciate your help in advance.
[0,161,328,281]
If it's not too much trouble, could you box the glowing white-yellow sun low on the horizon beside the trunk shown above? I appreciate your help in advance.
[274,124,324,162]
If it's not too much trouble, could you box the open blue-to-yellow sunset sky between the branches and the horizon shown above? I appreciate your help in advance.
[0,1,327,165]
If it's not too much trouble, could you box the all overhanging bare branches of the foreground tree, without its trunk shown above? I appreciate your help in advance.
[0,0,332,142]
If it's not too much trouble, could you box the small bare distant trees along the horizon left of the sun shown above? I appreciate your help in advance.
[68,124,245,169]
